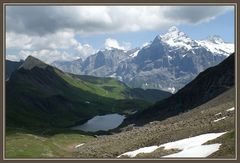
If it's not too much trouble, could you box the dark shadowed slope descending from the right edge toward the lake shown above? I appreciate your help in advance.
[126,54,235,124]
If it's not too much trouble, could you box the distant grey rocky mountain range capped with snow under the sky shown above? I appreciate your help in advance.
[52,27,234,93]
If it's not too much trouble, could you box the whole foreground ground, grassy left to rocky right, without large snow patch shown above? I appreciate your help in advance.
[6,89,235,159]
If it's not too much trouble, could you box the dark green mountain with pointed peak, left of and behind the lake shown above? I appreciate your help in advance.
[6,56,171,130]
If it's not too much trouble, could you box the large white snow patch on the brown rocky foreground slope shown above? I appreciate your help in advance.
[117,132,226,158]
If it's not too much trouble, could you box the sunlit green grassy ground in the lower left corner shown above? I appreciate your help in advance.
[5,129,94,158]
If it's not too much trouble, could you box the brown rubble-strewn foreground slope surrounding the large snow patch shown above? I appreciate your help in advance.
[72,88,235,158]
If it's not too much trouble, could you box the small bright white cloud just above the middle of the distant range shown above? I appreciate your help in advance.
[104,38,131,50]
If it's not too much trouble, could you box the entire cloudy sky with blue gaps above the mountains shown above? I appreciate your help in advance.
[6,6,234,63]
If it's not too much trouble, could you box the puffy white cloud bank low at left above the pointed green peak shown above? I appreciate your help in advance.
[6,30,95,63]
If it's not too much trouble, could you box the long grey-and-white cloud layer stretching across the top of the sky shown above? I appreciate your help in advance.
[6,6,234,35]
